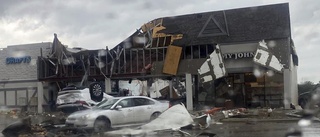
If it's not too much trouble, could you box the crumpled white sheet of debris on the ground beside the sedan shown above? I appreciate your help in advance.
[106,104,212,136]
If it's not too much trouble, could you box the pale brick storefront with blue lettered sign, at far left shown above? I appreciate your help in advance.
[0,42,52,112]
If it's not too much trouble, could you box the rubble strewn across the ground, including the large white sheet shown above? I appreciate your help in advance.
[0,104,310,137]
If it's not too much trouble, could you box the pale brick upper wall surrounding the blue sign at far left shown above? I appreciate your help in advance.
[0,42,52,81]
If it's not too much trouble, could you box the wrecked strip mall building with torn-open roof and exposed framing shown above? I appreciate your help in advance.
[0,4,298,112]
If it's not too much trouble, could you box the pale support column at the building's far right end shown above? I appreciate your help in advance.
[283,69,292,109]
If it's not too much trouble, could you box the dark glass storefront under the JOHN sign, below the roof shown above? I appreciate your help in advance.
[214,40,298,107]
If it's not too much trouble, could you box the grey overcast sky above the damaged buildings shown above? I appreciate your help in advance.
[0,0,320,83]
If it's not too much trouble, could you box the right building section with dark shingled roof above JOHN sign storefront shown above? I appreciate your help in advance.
[141,3,298,108]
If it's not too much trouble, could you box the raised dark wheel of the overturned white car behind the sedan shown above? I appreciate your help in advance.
[89,82,104,102]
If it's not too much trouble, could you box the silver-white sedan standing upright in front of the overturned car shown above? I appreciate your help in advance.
[66,96,170,132]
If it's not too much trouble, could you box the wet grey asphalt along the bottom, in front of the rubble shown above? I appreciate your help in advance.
[0,110,320,137]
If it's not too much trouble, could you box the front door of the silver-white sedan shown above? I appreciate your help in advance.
[113,98,135,125]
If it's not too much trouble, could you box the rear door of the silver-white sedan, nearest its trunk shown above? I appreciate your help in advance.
[133,98,155,122]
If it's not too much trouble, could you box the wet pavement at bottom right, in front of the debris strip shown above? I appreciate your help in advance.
[103,121,320,137]
